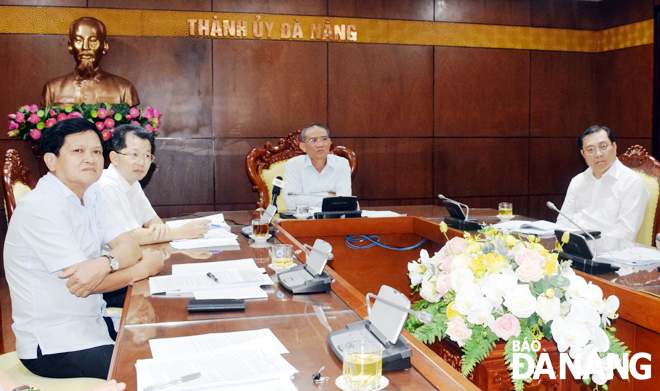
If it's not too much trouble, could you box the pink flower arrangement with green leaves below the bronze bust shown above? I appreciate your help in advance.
[7,103,161,150]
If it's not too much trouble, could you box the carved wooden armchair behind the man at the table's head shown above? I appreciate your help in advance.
[245,130,357,211]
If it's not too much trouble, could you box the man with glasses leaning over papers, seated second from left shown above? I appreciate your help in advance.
[94,125,211,244]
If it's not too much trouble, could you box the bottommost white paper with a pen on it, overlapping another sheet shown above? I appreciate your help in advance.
[135,338,298,391]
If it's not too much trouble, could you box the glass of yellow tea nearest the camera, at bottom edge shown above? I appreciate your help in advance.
[343,341,383,391]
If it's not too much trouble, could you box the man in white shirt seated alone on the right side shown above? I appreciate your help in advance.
[557,125,649,241]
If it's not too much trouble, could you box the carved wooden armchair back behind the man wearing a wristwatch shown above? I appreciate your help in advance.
[3,149,37,222]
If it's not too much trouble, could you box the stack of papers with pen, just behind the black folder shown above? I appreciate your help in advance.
[149,258,273,299]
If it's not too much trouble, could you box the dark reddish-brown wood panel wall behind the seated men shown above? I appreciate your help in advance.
[0,0,655,233]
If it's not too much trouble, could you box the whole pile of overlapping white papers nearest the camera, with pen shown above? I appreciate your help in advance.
[135,329,298,391]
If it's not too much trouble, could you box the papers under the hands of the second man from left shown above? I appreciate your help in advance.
[167,213,240,250]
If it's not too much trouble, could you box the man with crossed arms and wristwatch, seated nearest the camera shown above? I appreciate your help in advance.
[4,118,163,379]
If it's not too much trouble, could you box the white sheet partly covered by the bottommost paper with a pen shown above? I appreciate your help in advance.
[149,329,289,359]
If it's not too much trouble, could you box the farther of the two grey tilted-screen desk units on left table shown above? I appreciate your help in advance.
[277,239,334,295]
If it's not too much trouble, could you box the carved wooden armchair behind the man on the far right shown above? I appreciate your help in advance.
[619,145,660,246]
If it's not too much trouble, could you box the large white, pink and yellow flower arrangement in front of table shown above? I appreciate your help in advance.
[406,222,627,390]
